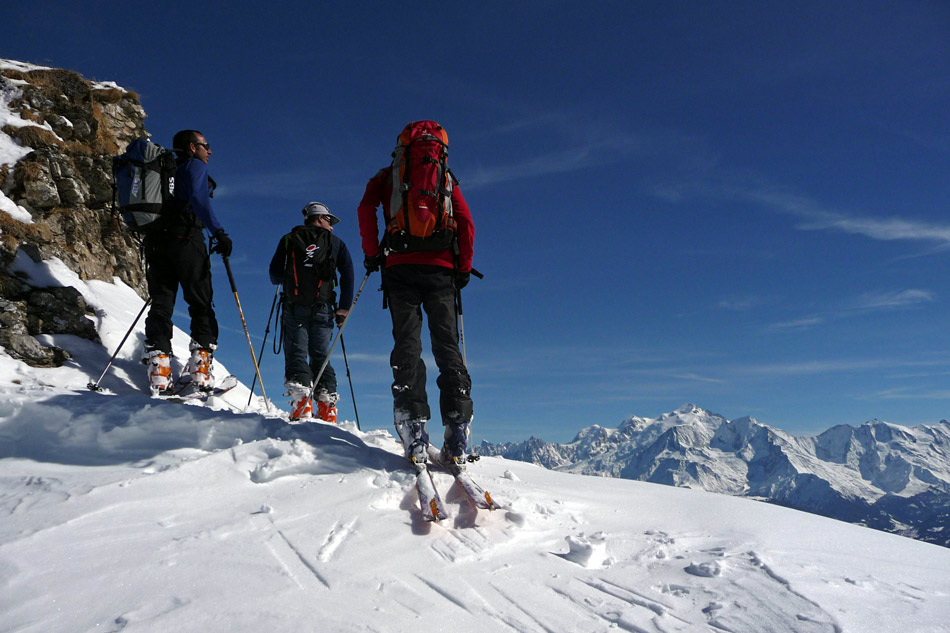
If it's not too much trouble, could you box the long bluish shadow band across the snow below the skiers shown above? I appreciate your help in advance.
[0,392,403,472]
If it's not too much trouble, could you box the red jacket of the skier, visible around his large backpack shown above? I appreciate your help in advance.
[358,167,475,273]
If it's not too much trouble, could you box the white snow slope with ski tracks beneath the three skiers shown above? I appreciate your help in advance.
[0,254,950,633]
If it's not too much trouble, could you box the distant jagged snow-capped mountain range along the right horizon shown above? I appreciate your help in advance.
[480,404,950,546]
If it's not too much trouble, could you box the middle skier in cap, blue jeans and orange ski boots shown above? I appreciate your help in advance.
[269,202,353,422]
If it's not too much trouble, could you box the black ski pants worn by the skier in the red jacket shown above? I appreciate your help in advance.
[383,264,473,424]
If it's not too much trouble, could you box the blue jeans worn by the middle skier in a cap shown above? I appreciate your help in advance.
[281,301,336,393]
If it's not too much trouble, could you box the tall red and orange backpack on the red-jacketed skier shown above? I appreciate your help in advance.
[386,121,456,253]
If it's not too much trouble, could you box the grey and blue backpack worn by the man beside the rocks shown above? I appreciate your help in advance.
[112,138,177,232]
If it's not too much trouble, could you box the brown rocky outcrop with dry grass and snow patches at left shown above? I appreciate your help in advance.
[0,60,147,366]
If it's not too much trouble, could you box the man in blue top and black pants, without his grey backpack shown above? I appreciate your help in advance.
[143,130,232,393]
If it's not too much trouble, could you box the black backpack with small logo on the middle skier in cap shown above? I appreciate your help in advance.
[284,226,336,306]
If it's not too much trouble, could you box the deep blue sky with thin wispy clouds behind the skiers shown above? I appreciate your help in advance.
[0,1,950,441]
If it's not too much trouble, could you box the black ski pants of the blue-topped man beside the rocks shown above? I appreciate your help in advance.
[144,228,218,354]
